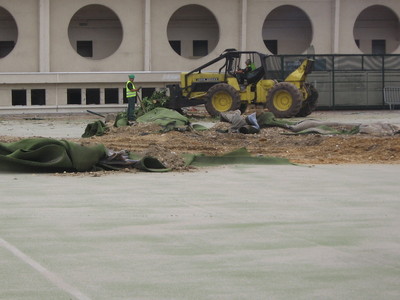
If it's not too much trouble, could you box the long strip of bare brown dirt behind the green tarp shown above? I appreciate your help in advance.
[80,120,400,164]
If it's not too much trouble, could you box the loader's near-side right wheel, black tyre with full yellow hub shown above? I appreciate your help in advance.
[265,82,303,118]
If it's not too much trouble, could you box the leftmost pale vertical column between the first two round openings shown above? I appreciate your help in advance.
[39,0,50,72]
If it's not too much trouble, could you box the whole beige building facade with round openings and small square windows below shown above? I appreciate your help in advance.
[0,0,400,113]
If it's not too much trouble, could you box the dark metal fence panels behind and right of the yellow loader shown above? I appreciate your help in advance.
[267,54,400,109]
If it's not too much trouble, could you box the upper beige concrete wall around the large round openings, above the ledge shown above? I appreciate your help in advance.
[0,0,400,72]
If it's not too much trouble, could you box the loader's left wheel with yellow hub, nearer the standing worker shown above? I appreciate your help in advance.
[205,83,241,117]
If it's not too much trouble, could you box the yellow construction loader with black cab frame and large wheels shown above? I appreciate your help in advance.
[167,49,318,118]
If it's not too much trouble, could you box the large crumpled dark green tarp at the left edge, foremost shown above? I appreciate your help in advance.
[0,138,170,173]
